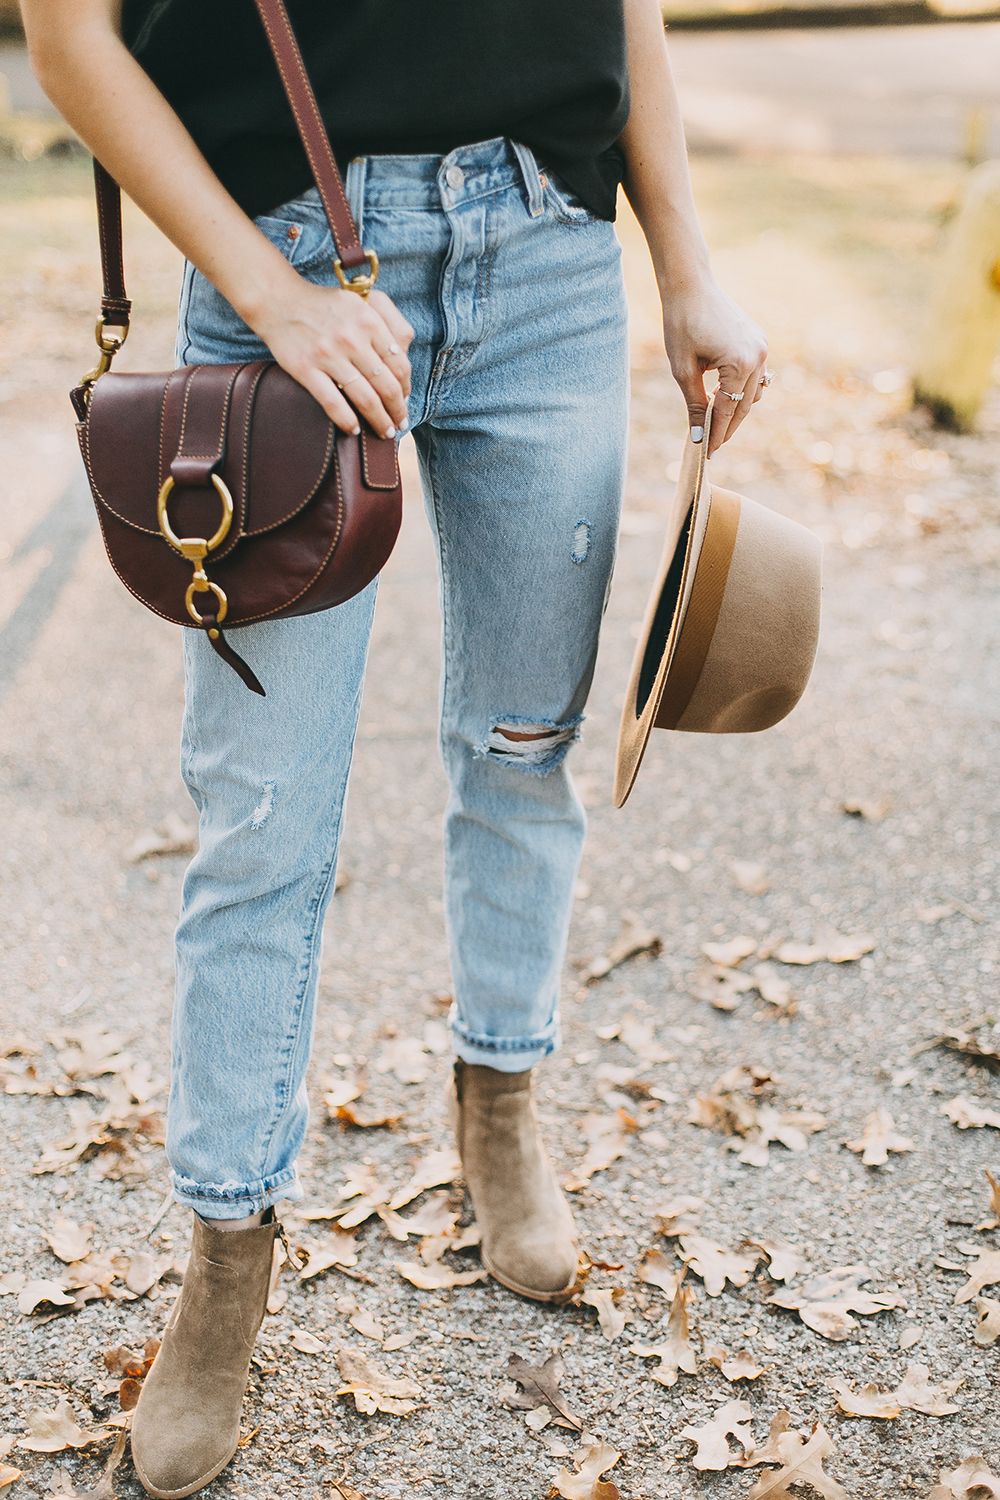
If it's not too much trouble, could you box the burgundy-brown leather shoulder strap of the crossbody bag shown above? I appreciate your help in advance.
[94,0,367,316]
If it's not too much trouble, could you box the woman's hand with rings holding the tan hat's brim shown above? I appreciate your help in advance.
[663,275,768,458]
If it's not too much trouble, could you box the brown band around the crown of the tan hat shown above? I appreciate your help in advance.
[654,486,741,729]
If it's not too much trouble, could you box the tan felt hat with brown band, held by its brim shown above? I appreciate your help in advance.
[615,404,823,807]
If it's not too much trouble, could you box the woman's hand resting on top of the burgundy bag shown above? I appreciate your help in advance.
[252,275,414,438]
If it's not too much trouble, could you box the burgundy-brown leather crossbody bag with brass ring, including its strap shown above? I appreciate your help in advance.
[72,0,402,695]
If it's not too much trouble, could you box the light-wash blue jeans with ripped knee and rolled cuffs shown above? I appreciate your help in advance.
[166,140,628,1218]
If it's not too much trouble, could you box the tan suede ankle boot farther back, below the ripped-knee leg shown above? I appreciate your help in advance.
[450,1061,577,1302]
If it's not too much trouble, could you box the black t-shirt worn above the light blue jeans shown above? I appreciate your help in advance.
[121,0,628,219]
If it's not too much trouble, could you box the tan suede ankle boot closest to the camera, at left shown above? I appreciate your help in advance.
[132,1214,279,1500]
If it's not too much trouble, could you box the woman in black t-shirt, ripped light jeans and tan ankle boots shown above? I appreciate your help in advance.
[24,0,766,1497]
